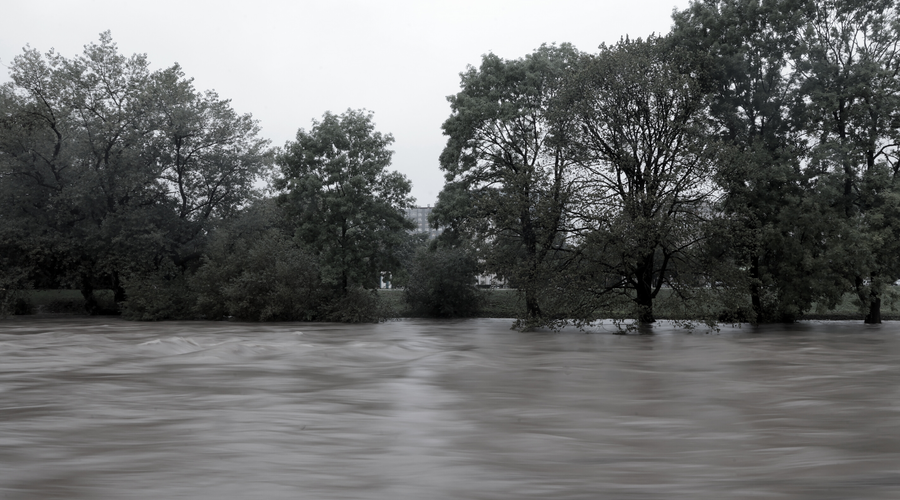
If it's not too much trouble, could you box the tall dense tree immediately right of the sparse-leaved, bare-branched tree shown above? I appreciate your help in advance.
[670,0,824,322]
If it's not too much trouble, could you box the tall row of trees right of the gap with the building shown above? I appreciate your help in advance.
[434,0,900,326]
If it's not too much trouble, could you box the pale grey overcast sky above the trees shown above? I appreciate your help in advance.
[0,0,689,206]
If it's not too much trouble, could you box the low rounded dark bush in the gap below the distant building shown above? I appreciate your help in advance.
[404,246,482,318]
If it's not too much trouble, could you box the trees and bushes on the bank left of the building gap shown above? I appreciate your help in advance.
[0,33,414,321]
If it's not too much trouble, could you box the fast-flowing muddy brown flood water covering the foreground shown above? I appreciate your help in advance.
[0,318,900,500]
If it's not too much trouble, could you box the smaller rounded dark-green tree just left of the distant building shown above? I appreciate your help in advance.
[274,110,414,295]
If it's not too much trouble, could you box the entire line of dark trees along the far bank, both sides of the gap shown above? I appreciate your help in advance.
[0,0,900,327]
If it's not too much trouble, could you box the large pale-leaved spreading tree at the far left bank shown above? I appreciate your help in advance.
[0,32,269,312]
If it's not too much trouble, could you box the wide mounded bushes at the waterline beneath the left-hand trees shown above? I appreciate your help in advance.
[122,199,394,322]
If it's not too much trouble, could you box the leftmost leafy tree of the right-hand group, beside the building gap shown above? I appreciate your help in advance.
[434,44,578,326]
